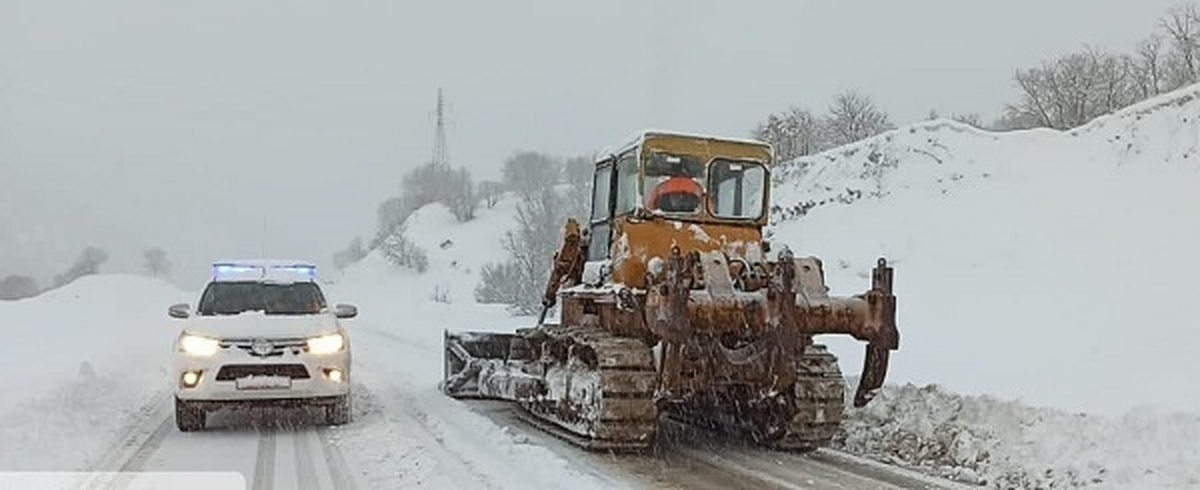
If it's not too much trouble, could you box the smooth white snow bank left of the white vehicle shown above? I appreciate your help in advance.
[0,275,190,471]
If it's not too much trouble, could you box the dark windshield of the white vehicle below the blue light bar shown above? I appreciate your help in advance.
[197,282,325,316]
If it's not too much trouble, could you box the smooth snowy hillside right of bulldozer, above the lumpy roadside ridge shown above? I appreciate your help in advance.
[774,85,1200,414]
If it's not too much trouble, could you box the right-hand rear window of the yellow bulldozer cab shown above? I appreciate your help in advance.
[708,160,767,220]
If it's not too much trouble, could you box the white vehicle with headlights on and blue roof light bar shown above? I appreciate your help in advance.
[168,261,358,431]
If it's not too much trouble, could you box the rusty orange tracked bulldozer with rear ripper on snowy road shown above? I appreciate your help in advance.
[440,131,899,452]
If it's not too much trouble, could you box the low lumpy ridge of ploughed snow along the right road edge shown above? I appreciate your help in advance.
[835,384,1200,489]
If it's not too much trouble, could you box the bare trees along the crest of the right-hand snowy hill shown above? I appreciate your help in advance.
[752,4,1200,154]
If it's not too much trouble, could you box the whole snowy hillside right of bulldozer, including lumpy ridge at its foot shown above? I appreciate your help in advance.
[772,85,1200,488]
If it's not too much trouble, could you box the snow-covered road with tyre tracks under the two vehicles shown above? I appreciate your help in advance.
[65,314,953,489]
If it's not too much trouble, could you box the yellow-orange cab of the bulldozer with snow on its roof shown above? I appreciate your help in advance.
[588,131,772,287]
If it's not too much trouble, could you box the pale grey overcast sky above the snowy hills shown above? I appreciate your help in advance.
[0,0,1177,287]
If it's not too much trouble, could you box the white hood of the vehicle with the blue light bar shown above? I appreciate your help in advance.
[185,312,337,339]
